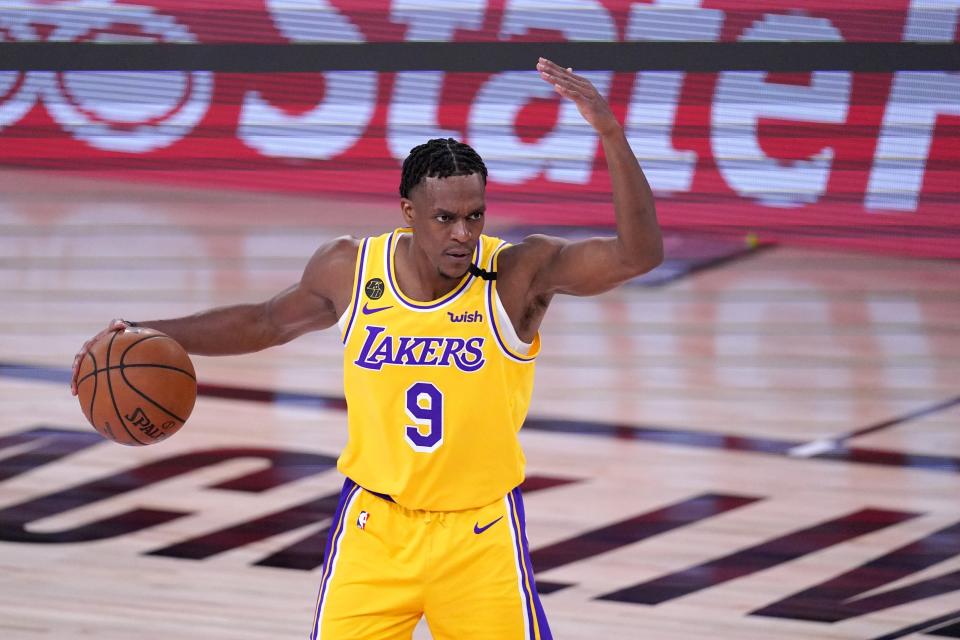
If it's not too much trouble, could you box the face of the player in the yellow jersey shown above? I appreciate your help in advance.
[400,173,486,279]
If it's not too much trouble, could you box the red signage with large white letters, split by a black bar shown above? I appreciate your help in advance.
[0,0,960,258]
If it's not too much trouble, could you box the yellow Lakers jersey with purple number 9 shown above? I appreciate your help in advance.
[337,229,540,511]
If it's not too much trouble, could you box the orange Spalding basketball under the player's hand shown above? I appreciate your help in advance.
[77,327,197,446]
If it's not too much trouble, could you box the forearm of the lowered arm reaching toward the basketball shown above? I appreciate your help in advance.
[136,304,286,356]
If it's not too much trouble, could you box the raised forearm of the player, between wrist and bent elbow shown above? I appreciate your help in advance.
[600,126,663,271]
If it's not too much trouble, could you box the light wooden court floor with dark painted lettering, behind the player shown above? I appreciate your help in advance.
[0,170,960,640]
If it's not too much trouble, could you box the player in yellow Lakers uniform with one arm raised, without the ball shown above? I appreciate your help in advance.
[74,58,662,640]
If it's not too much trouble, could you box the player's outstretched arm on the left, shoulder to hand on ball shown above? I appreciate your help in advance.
[70,237,359,395]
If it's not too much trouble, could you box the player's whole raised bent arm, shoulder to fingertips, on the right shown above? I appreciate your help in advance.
[531,58,663,296]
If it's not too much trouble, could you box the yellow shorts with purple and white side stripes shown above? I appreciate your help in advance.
[310,478,551,640]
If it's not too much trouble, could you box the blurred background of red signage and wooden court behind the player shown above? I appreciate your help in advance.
[0,0,960,639]
